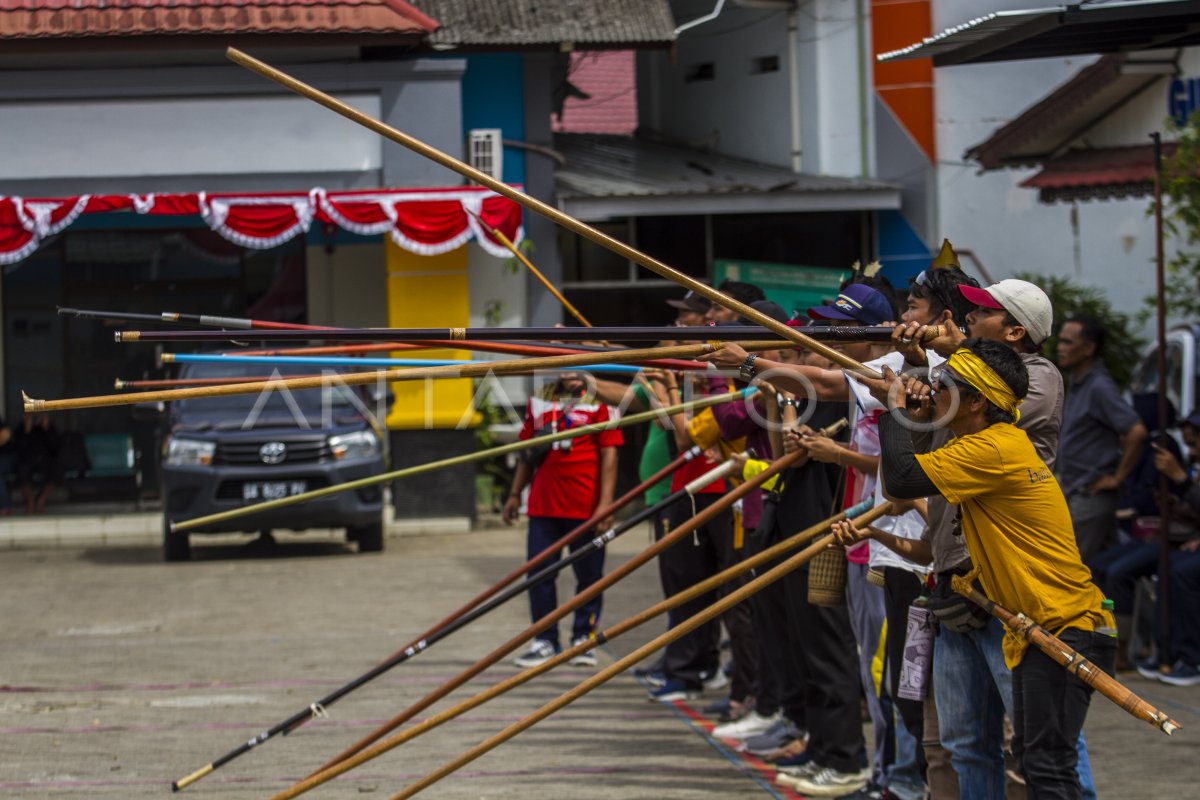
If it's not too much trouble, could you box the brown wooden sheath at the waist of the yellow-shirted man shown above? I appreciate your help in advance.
[950,576,1182,736]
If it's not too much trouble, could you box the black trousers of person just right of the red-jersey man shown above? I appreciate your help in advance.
[659,494,744,697]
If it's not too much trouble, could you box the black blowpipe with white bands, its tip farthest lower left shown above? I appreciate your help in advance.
[170,450,710,792]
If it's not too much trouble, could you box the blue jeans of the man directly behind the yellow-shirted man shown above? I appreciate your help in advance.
[934,619,1096,800]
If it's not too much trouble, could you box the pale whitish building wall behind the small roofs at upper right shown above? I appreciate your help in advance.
[934,0,1165,328]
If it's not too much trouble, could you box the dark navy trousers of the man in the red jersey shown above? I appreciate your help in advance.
[526,517,604,650]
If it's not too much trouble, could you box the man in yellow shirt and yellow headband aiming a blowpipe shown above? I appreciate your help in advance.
[841,338,1116,798]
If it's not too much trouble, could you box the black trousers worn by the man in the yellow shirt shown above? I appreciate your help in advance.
[1013,627,1117,800]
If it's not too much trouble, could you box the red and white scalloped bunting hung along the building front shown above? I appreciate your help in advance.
[0,187,524,264]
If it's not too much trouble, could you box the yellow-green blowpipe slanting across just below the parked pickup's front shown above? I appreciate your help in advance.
[172,390,752,533]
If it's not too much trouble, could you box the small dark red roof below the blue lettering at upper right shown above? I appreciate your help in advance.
[1021,143,1175,203]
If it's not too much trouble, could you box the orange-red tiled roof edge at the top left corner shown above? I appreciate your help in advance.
[0,0,438,40]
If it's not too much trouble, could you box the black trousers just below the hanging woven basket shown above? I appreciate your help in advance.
[785,566,866,772]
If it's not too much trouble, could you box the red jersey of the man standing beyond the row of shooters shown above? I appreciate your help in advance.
[520,397,625,519]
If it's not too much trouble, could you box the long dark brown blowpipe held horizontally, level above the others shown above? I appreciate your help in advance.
[113,325,941,345]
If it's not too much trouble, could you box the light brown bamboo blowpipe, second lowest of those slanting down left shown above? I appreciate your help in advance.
[271,500,890,800]
